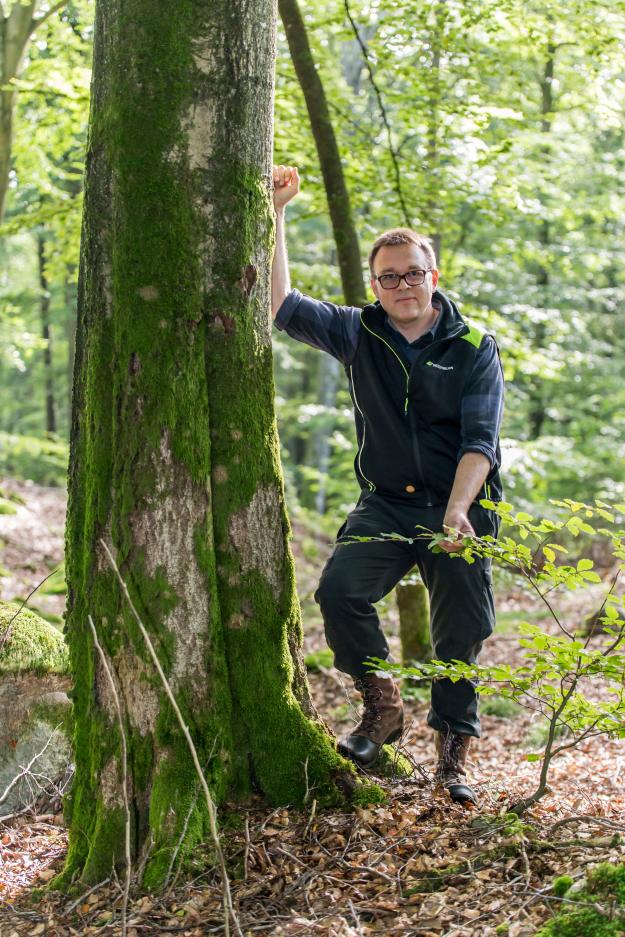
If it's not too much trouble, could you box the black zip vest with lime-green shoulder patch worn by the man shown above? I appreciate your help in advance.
[345,291,502,505]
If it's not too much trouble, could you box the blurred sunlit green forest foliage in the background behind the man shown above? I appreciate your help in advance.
[0,0,625,514]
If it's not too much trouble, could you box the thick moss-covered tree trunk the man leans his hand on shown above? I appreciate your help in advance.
[65,0,353,886]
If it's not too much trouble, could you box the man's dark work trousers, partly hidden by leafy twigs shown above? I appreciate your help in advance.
[315,492,498,738]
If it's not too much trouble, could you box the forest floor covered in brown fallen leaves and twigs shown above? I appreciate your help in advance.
[0,479,625,937]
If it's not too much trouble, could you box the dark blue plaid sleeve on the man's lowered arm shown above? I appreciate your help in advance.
[458,335,504,469]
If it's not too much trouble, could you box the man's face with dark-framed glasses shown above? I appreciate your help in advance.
[371,244,438,325]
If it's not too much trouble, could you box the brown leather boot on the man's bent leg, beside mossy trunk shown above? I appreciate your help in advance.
[338,673,404,767]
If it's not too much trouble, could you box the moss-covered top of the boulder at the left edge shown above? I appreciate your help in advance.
[0,601,69,674]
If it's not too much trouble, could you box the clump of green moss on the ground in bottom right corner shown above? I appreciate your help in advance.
[535,862,625,937]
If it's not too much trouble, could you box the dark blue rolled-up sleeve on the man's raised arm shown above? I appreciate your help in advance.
[274,290,360,364]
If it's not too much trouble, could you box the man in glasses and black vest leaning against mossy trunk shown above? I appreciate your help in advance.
[271,166,503,803]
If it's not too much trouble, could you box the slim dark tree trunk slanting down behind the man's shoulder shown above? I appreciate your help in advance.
[278,0,367,306]
